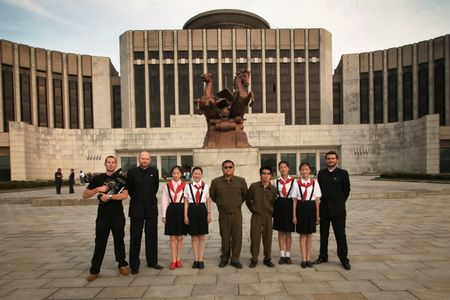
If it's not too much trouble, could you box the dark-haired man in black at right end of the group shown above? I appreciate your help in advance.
[315,151,351,270]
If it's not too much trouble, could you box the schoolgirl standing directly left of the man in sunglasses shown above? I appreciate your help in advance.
[184,167,211,269]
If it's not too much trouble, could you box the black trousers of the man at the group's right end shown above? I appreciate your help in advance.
[320,216,349,263]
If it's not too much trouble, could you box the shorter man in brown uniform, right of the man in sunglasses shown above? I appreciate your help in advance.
[245,166,278,268]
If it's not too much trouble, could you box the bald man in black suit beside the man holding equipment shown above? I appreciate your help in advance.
[127,151,163,274]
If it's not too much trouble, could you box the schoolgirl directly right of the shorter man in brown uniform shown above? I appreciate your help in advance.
[273,161,298,265]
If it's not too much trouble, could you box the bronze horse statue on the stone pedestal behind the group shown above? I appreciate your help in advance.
[194,70,254,149]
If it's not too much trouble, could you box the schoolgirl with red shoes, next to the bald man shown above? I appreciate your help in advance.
[161,166,187,270]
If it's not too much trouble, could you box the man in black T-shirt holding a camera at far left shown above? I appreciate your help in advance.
[83,156,128,281]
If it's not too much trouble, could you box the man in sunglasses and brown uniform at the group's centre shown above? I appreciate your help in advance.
[209,160,247,269]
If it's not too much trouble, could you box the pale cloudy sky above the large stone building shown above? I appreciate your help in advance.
[0,0,450,71]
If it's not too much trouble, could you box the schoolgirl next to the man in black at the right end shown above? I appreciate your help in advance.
[292,163,322,269]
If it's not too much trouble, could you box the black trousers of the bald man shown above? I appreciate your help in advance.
[130,208,158,269]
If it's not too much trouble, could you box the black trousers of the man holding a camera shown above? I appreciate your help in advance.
[90,216,128,274]
